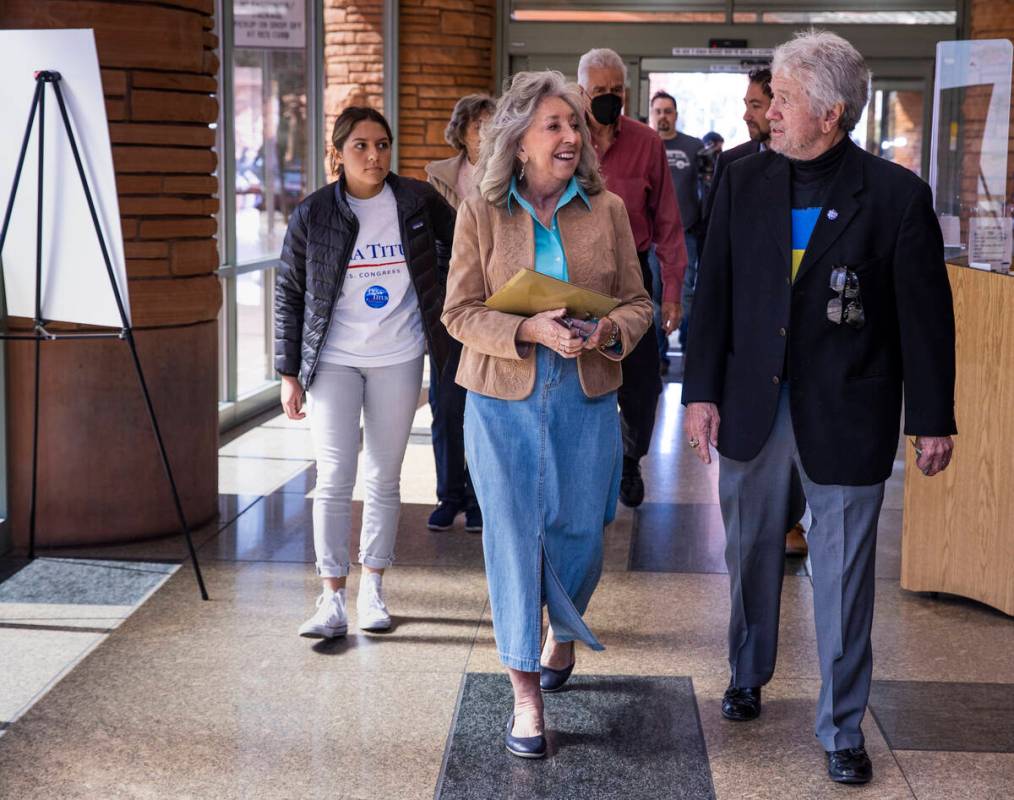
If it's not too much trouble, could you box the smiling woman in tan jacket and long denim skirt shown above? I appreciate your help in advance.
[442,72,652,757]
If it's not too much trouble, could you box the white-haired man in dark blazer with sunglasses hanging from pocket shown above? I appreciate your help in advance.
[683,31,956,783]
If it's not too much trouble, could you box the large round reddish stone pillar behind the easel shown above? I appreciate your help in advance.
[0,0,221,548]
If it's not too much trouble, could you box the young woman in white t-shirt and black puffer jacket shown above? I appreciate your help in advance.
[275,106,454,638]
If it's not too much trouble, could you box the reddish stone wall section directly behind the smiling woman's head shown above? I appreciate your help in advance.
[399,0,496,177]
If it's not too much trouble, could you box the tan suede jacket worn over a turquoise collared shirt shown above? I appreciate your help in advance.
[441,192,652,399]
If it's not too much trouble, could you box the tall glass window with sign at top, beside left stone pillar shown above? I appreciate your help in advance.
[216,0,323,421]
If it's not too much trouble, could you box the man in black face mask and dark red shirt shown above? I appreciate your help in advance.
[577,49,686,508]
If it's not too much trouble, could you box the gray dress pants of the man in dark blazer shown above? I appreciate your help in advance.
[719,385,884,750]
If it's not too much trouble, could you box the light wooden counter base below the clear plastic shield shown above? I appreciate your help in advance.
[901,265,1014,614]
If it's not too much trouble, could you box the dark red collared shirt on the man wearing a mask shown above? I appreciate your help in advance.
[599,116,686,302]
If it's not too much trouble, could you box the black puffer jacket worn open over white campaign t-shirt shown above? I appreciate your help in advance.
[275,172,454,388]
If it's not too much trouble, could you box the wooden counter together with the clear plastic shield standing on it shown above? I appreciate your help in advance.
[901,40,1014,614]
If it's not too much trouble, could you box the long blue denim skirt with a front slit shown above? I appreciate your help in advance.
[464,346,623,672]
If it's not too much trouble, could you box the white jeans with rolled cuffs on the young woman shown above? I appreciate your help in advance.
[307,356,423,578]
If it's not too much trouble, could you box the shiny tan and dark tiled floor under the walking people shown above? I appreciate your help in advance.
[0,365,1014,800]
